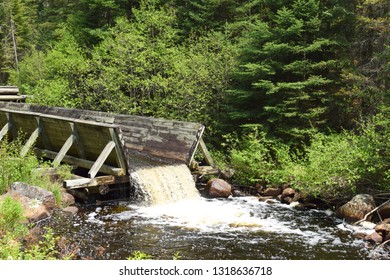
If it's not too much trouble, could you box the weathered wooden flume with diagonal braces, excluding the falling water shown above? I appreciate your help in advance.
[0,94,213,199]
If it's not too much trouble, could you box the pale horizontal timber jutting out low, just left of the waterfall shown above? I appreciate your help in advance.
[63,175,130,190]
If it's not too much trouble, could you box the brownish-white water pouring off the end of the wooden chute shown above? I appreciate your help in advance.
[129,155,200,206]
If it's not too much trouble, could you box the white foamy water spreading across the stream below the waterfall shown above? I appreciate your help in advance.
[106,197,342,245]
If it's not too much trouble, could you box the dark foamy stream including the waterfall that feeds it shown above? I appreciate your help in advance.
[44,160,376,260]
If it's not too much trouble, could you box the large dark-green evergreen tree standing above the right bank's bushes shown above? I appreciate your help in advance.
[229,0,354,142]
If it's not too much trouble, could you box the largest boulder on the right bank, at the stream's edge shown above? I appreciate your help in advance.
[336,194,376,222]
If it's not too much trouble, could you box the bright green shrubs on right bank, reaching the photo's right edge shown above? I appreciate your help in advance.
[285,112,390,198]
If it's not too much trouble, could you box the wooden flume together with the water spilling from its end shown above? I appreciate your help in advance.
[0,102,205,204]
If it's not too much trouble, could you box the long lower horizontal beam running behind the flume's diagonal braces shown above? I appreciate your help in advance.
[35,148,126,176]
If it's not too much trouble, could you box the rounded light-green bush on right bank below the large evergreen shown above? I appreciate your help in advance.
[285,133,367,198]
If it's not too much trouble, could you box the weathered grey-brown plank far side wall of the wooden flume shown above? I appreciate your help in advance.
[0,102,204,164]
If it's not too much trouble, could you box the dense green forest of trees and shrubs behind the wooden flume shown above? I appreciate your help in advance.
[0,0,390,199]
